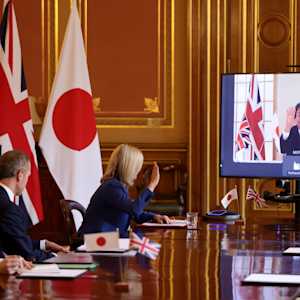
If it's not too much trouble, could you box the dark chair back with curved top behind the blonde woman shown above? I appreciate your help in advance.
[59,199,86,250]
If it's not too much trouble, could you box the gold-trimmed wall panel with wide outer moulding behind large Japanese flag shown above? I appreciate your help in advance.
[32,0,187,143]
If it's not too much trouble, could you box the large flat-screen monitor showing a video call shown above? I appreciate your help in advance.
[220,73,300,178]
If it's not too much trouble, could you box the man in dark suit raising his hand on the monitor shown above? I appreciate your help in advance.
[280,102,300,155]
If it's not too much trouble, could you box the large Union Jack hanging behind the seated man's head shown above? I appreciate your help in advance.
[0,0,43,224]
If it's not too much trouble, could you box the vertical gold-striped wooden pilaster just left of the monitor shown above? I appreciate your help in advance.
[188,0,230,213]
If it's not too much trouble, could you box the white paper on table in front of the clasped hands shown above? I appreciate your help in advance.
[17,269,87,279]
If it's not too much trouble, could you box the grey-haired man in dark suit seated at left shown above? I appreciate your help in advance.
[0,150,68,261]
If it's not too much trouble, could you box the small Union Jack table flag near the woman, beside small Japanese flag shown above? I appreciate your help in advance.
[130,232,161,259]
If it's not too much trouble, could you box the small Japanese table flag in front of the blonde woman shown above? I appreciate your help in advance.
[84,231,119,251]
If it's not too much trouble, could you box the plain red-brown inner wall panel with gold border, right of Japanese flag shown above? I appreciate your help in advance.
[86,0,174,126]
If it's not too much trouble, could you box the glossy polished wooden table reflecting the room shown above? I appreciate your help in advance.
[0,220,300,300]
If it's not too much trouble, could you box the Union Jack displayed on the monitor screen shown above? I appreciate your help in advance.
[236,74,265,160]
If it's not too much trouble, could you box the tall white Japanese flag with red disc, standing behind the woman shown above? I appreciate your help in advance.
[39,1,102,213]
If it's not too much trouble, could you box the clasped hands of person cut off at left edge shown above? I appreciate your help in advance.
[0,255,32,274]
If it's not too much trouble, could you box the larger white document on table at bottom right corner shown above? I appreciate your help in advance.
[243,273,300,284]
